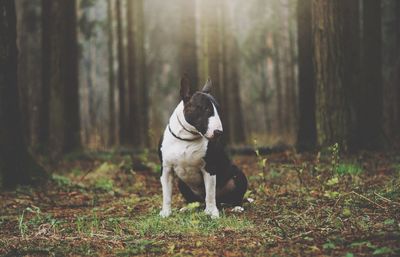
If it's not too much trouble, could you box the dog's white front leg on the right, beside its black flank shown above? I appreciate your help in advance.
[202,169,219,219]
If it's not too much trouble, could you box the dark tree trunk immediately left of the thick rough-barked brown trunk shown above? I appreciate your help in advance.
[297,0,317,151]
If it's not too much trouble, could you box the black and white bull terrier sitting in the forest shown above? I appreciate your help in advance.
[159,76,247,218]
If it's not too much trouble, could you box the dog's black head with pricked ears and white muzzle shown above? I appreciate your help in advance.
[180,76,223,139]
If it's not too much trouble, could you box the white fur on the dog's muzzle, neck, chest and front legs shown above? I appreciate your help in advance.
[160,102,222,218]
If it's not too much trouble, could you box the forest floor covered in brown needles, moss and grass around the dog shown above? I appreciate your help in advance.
[0,147,400,257]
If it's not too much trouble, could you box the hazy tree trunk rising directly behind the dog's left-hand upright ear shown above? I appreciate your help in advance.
[179,0,199,92]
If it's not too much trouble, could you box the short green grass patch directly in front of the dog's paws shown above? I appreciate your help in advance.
[132,210,254,236]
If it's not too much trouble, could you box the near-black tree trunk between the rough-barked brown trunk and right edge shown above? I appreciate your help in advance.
[357,0,383,149]
